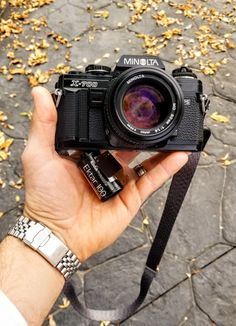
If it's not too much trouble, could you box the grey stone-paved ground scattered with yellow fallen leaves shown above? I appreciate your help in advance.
[0,0,236,326]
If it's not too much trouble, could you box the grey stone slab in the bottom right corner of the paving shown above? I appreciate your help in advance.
[193,249,236,326]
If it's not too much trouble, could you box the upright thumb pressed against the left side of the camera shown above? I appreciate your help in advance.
[28,86,57,151]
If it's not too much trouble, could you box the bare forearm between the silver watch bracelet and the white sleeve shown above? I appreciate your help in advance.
[0,236,64,326]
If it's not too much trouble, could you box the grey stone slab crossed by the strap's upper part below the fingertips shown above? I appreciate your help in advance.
[145,166,224,258]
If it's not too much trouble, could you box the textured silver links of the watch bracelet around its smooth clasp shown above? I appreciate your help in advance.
[8,215,81,280]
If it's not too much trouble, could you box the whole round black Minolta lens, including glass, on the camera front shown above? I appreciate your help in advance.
[106,67,184,146]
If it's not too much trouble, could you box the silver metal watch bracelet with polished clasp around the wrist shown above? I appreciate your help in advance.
[8,216,81,280]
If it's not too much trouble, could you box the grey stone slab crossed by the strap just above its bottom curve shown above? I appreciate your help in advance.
[84,247,188,309]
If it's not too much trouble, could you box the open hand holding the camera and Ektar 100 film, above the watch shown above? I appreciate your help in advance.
[22,87,188,261]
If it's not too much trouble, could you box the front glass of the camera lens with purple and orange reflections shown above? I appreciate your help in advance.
[122,85,168,129]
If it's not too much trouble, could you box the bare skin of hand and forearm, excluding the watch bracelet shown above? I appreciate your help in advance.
[0,87,188,325]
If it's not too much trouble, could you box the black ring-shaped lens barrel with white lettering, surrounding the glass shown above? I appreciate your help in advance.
[105,68,184,148]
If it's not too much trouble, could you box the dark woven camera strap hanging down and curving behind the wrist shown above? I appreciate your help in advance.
[64,152,200,322]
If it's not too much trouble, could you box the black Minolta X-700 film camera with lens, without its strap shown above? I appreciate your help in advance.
[55,55,209,153]
